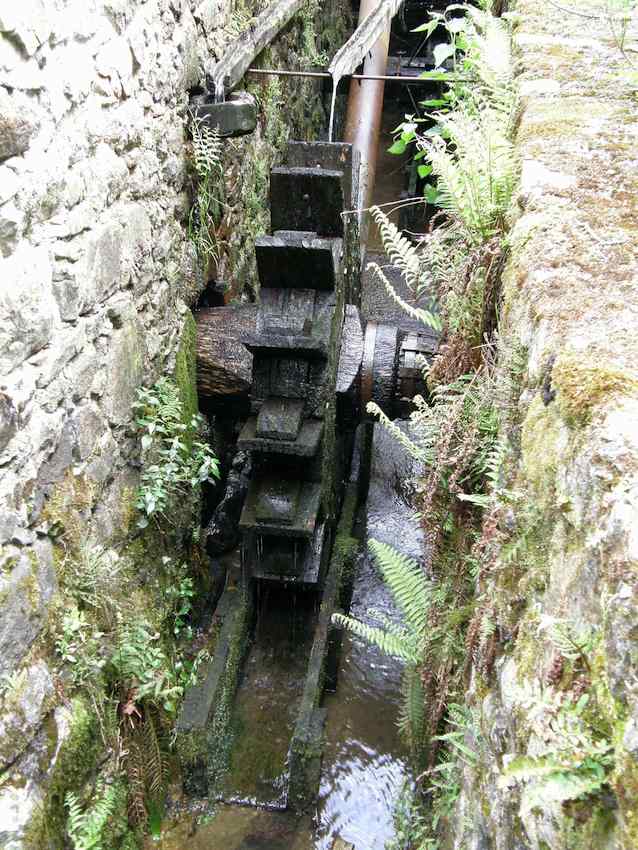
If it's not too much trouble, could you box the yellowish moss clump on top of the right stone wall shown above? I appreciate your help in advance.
[552,352,638,425]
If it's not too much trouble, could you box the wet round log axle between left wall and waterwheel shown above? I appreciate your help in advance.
[195,304,257,401]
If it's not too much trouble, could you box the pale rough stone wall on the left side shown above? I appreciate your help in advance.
[0,0,349,848]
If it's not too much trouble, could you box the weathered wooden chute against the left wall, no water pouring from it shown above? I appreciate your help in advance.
[209,0,305,100]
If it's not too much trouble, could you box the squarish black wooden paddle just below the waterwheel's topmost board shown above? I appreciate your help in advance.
[270,166,347,237]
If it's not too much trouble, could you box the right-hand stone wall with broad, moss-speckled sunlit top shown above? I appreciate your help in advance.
[448,0,638,850]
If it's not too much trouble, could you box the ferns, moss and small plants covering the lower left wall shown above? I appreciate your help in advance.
[37,362,217,850]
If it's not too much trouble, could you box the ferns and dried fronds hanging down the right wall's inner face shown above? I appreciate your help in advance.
[332,6,517,850]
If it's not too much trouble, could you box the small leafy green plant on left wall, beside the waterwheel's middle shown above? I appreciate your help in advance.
[134,378,219,528]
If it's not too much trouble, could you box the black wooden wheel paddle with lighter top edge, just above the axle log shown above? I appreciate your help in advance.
[255,230,343,290]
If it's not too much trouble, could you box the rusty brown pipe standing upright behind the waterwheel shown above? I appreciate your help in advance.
[344,0,390,242]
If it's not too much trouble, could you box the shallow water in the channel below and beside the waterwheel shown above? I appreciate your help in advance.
[154,426,423,850]
